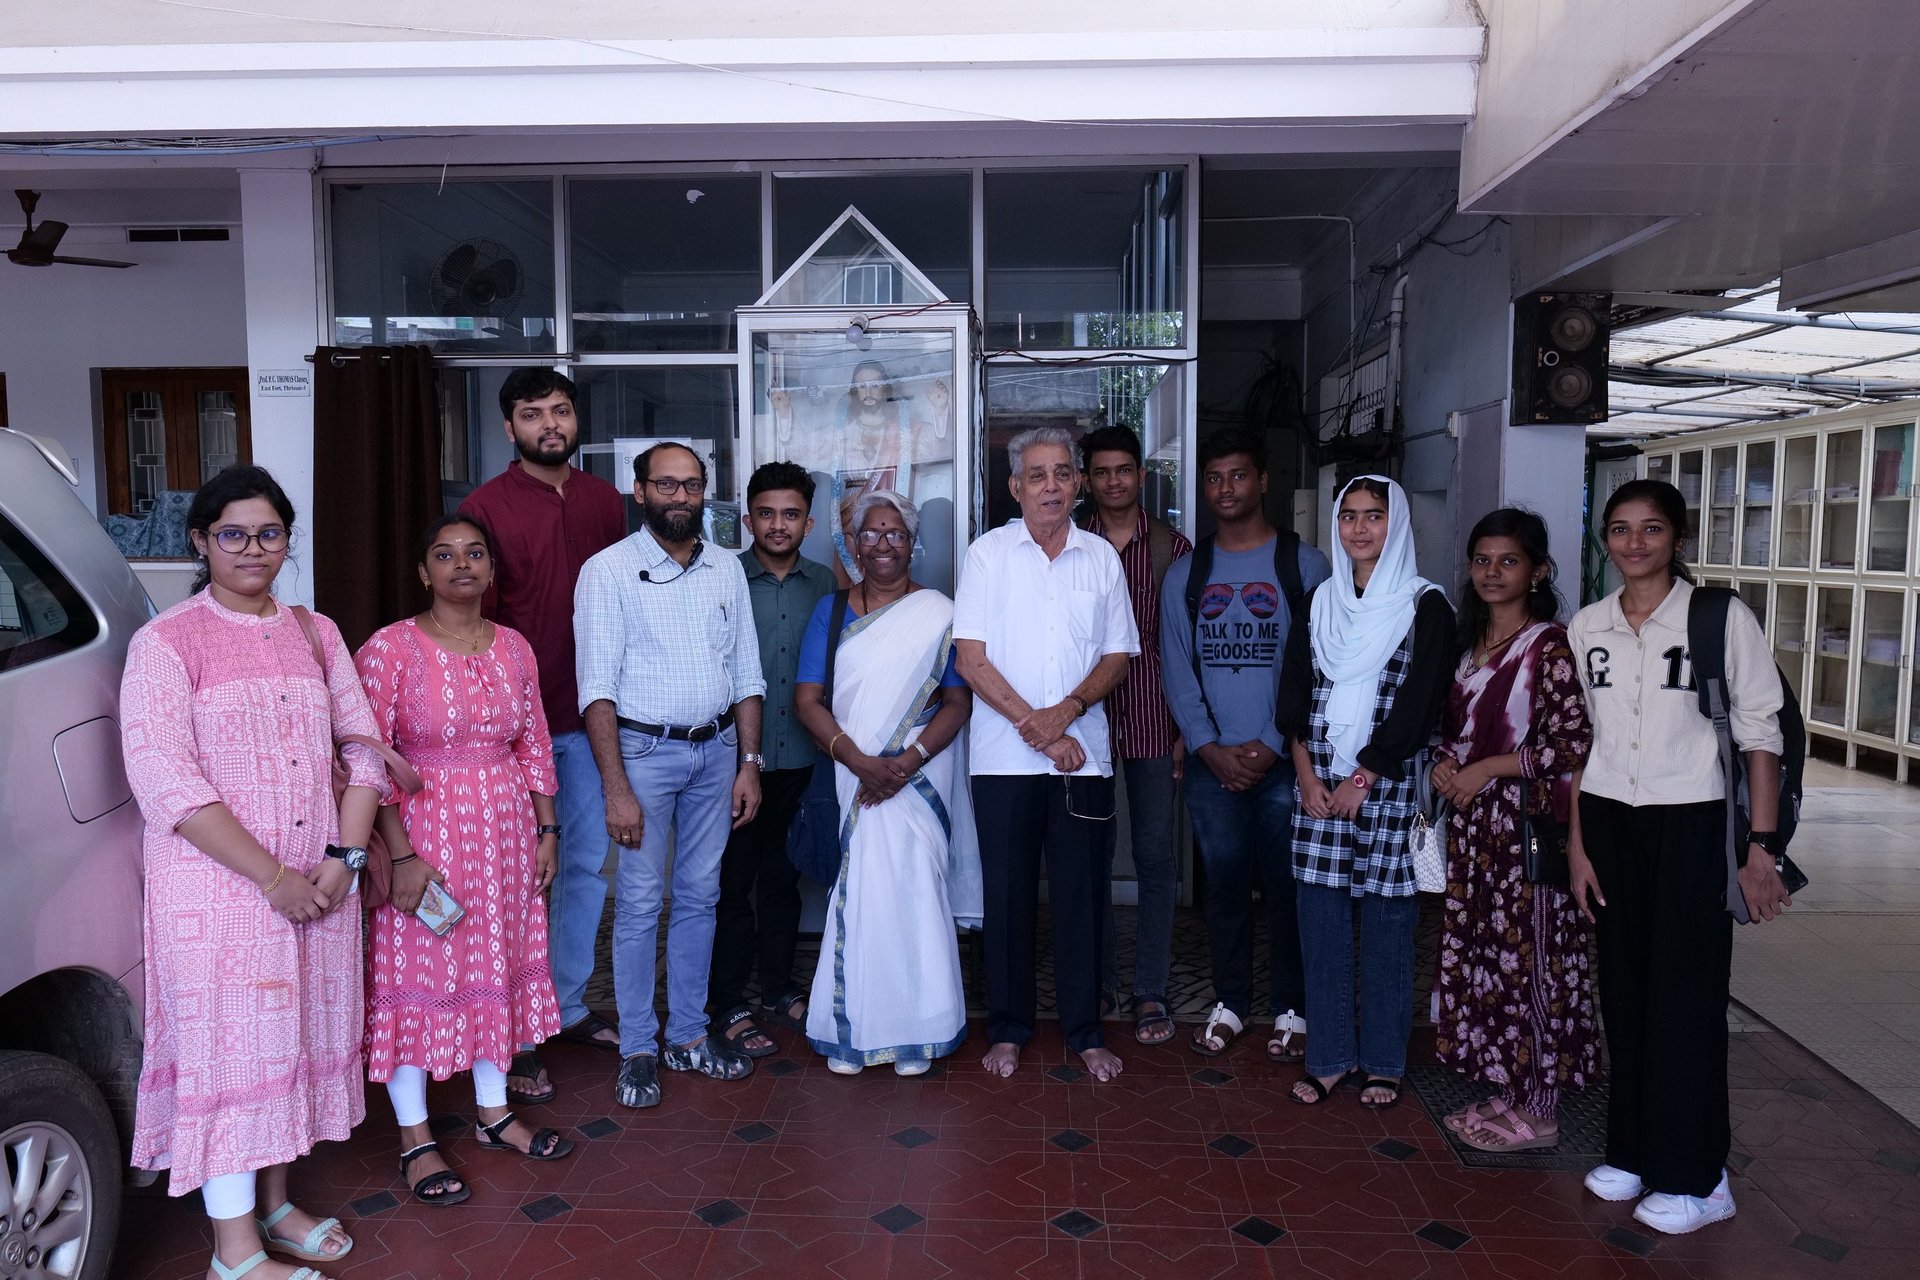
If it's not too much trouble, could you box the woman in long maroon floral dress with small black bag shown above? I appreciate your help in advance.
[1434,507,1599,1151]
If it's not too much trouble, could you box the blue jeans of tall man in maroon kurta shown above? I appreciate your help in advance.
[547,729,609,1027]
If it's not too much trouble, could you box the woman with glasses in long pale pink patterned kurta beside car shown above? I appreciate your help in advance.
[121,466,386,1280]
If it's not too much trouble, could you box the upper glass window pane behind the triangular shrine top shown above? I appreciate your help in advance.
[774,173,973,305]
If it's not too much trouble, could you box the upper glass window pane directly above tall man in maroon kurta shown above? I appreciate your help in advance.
[566,175,760,351]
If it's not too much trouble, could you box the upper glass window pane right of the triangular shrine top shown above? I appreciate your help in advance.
[985,169,1187,349]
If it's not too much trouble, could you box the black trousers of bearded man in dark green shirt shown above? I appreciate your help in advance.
[707,764,814,1017]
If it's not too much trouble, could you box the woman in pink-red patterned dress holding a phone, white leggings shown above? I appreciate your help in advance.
[355,516,572,1205]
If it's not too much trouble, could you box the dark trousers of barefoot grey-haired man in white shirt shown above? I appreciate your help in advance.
[973,773,1116,1050]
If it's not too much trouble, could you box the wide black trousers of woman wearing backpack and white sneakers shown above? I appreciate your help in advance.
[1580,794,1734,1196]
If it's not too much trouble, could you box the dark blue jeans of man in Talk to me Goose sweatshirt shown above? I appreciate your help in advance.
[1187,756,1317,1032]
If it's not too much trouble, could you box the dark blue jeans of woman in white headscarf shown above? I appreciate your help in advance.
[1298,885,1421,1080]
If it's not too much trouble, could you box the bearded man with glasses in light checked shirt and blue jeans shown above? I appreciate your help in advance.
[574,443,766,1107]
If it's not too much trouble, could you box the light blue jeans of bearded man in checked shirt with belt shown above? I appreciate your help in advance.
[612,729,737,1057]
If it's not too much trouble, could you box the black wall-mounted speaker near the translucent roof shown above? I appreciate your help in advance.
[1507,294,1613,426]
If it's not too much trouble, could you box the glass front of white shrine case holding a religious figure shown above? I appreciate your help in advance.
[753,328,958,595]
